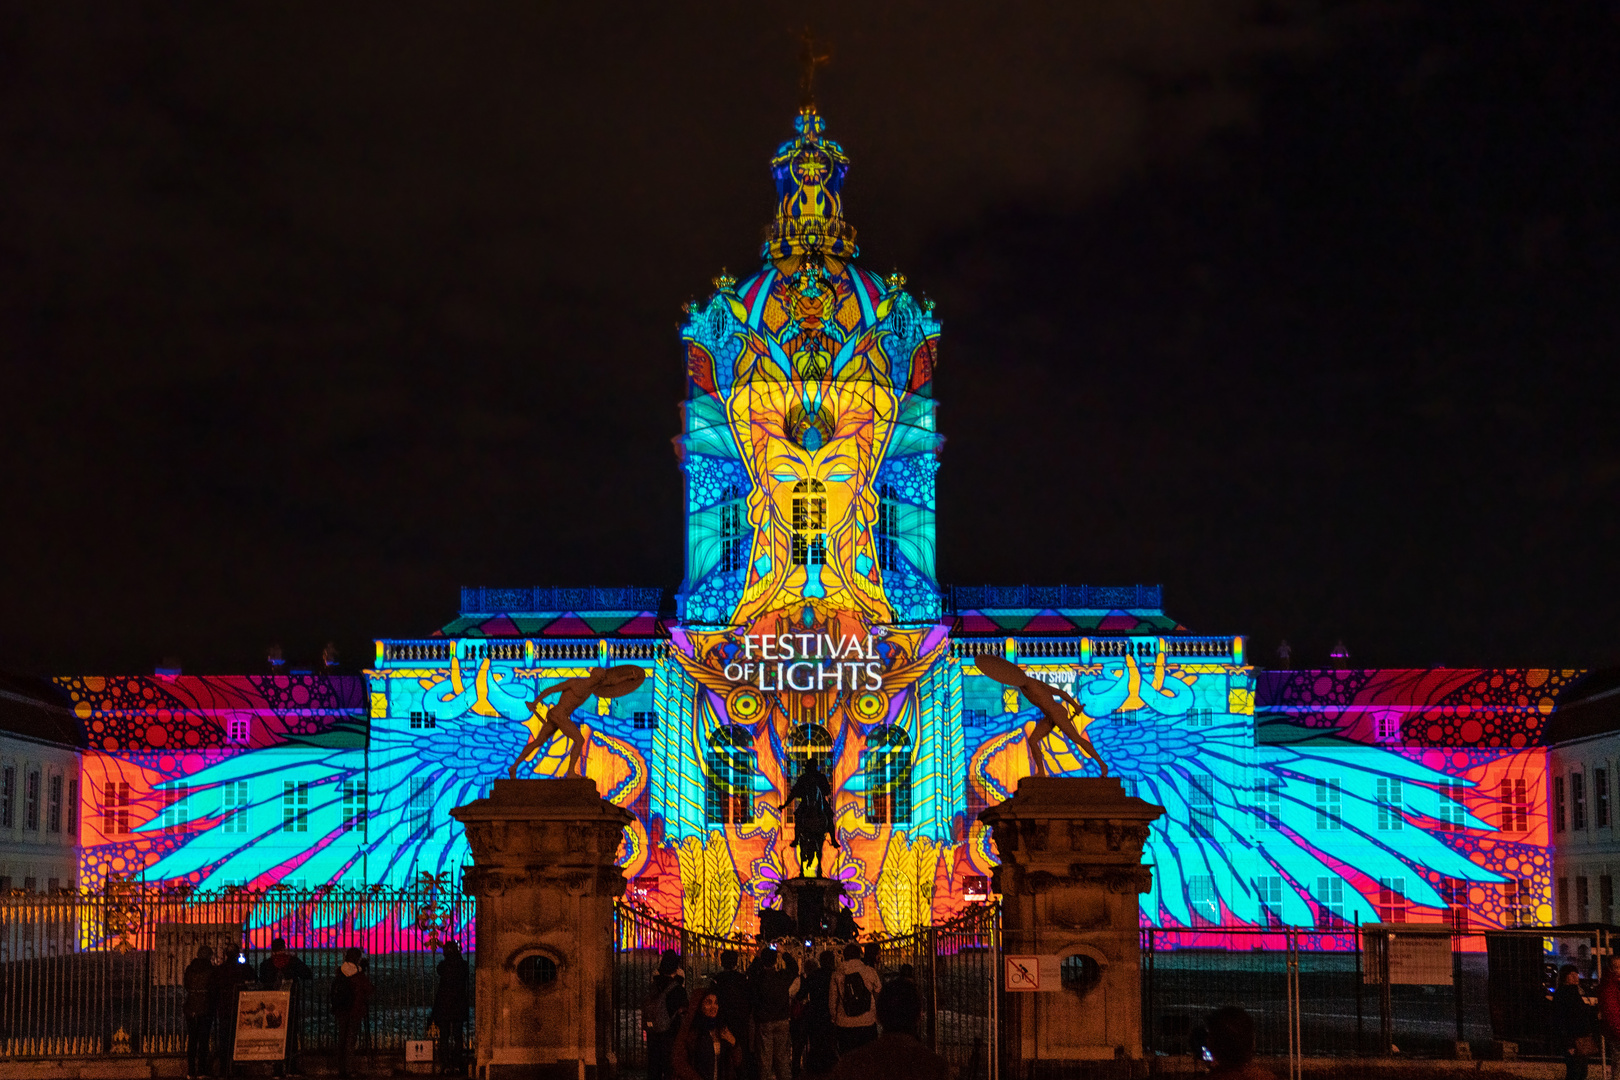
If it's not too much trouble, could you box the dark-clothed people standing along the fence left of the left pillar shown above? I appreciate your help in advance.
[181,938,471,1080]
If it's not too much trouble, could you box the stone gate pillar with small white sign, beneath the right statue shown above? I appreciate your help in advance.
[978,776,1165,1077]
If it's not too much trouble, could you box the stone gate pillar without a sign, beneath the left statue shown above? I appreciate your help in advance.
[450,780,632,1080]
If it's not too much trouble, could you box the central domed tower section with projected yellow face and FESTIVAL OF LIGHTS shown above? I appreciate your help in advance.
[651,105,961,929]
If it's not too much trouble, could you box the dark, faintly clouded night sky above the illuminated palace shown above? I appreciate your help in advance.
[0,0,1620,674]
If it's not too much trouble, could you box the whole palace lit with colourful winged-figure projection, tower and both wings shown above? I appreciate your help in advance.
[60,108,1576,933]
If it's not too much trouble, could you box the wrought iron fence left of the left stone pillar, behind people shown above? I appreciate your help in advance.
[0,879,475,1057]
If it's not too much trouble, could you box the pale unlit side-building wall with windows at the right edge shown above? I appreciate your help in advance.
[1547,732,1620,925]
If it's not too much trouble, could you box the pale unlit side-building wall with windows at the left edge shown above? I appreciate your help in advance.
[0,732,79,892]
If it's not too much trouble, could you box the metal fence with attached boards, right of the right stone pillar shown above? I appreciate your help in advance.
[1142,923,1614,1062]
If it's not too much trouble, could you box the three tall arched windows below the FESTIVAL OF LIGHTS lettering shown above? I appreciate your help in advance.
[703,724,912,826]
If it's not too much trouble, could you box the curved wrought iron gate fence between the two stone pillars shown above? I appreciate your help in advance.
[612,904,1000,1080]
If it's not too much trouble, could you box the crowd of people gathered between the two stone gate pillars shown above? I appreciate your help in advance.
[642,942,949,1080]
